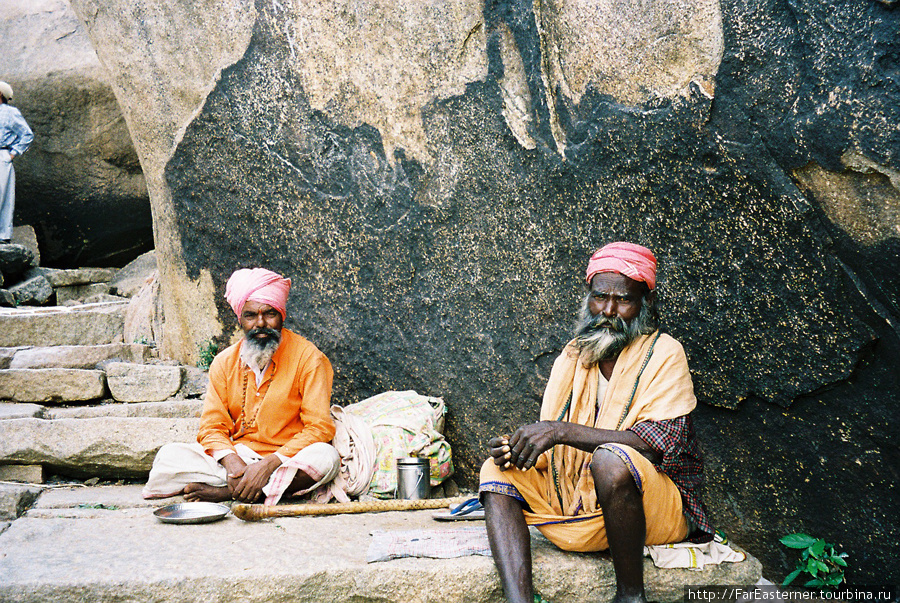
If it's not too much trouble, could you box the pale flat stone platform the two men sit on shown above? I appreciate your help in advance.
[0,485,761,603]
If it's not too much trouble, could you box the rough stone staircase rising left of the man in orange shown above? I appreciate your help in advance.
[0,237,206,484]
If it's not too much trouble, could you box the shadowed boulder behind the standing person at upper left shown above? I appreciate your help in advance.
[0,0,153,267]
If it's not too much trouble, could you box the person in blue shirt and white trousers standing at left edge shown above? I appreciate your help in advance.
[0,82,34,243]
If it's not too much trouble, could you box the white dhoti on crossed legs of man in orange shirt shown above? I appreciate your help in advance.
[142,442,341,505]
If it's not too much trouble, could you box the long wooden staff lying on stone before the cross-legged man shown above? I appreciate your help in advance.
[231,497,466,521]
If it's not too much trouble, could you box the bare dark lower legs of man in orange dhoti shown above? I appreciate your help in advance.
[481,448,647,603]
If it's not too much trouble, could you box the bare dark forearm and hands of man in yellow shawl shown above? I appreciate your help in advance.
[490,421,659,469]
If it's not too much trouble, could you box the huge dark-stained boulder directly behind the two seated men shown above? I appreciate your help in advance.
[73,0,900,583]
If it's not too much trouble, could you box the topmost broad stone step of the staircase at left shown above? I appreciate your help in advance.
[0,300,128,347]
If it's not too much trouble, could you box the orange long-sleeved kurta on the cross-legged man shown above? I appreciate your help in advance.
[197,329,334,457]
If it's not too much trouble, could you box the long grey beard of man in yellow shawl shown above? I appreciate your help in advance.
[575,296,656,366]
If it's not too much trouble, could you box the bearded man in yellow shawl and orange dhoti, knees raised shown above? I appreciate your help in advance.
[479,242,714,603]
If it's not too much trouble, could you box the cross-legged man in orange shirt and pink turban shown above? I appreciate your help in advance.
[143,268,340,504]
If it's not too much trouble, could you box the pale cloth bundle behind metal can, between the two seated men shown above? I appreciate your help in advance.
[331,390,453,500]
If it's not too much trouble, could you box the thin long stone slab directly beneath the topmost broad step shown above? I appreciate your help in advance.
[0,343,155,369]
